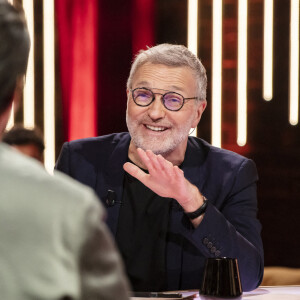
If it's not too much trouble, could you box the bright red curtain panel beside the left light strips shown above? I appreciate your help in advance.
[55,0,98,140]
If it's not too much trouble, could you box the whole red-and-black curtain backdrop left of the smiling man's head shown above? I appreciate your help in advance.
[55,0,155,140]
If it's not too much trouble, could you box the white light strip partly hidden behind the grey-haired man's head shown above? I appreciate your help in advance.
[187,0,198,136]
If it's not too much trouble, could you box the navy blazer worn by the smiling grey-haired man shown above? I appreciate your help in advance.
[55,132,264,291]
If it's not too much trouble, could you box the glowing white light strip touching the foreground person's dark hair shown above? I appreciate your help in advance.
[23,0,34,127]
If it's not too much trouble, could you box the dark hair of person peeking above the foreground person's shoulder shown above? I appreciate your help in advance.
[2,124,45,153]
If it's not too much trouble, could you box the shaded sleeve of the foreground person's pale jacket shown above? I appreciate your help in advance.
[80,196,130,300]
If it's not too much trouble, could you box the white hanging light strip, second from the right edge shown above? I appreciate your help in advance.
[263,0,273,101]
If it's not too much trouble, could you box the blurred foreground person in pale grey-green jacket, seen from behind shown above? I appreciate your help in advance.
[0,0,129,300]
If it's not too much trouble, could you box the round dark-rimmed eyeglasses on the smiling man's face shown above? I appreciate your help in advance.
[131,87,198,111]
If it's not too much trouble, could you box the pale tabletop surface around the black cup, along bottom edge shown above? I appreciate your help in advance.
[131,285,300,300]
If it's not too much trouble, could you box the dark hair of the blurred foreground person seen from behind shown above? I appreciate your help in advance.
[0,0,30,114]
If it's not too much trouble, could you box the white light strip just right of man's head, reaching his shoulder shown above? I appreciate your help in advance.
[212,0,222,147]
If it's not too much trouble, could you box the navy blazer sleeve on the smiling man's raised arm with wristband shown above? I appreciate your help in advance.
[182,159,264,291]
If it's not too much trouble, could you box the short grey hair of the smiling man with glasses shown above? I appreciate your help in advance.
[127,44,207,100]
